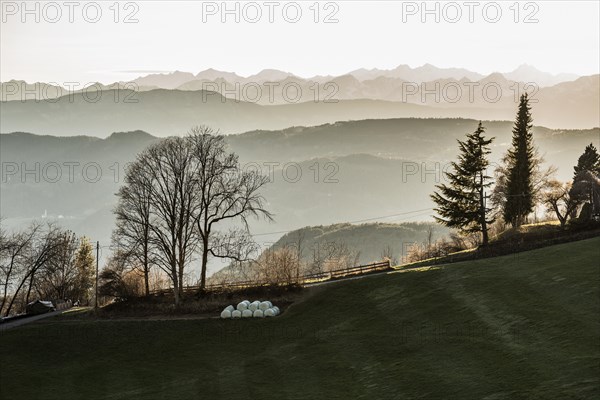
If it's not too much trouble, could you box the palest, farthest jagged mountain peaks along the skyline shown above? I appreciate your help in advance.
[0,64,579,104]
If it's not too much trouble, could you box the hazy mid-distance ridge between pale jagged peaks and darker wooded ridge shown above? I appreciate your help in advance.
[0,74,600,137]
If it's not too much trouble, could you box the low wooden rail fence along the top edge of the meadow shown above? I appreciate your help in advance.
[152,260,392,294]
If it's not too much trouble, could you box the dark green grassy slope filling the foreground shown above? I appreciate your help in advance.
[0,238,600,400]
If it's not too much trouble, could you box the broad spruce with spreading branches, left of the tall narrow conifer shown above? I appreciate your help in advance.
[431,122,494,245]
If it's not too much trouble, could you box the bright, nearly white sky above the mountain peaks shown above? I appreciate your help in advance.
[0,0,600,83]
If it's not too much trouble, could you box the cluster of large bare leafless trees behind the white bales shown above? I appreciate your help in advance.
[107,126,272,305]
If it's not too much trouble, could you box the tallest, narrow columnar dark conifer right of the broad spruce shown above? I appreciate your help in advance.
[503,94,536,227]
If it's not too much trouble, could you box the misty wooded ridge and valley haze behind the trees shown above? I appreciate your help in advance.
[0,118,600,271]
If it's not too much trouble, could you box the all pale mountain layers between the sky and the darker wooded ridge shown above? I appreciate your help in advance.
[0,64,600,132]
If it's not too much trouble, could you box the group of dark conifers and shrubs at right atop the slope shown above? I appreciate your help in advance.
[431,94,600,246]
